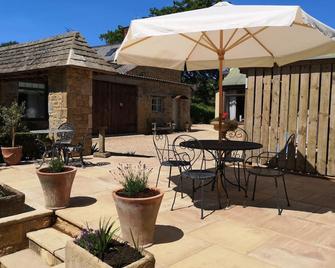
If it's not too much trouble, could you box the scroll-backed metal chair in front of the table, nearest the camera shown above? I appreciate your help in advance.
[171,135,221,219]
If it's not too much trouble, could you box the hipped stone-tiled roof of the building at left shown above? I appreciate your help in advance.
[0,32,115,73]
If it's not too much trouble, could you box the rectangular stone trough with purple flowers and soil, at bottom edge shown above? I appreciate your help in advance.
[65,220,155,268]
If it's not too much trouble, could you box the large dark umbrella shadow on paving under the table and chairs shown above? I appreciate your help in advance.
[166,167,335,217]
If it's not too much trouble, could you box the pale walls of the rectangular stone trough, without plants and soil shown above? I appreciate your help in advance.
[65,241,155,268]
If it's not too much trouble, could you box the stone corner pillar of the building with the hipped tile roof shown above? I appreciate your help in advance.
[48,67,92,154]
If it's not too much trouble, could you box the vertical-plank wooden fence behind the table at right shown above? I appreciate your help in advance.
[245,60,335,176]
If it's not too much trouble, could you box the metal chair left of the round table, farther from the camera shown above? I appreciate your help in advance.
[152,131,190,187]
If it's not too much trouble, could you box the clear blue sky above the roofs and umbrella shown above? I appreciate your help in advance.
[0,0,335,45]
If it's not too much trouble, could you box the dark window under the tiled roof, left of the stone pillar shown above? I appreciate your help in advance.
[18,82,48,120]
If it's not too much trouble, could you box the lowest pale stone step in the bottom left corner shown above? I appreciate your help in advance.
[0,249,50,268]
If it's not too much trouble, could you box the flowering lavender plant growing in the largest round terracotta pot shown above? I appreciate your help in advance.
[118,162,152,197]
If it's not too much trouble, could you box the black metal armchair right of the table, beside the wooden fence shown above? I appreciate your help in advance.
[246,134,295,215]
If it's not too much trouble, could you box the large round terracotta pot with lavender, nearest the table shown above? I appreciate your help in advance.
[113,162,164,246]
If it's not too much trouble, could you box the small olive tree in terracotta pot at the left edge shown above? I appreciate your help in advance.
[0,102,24,165]
